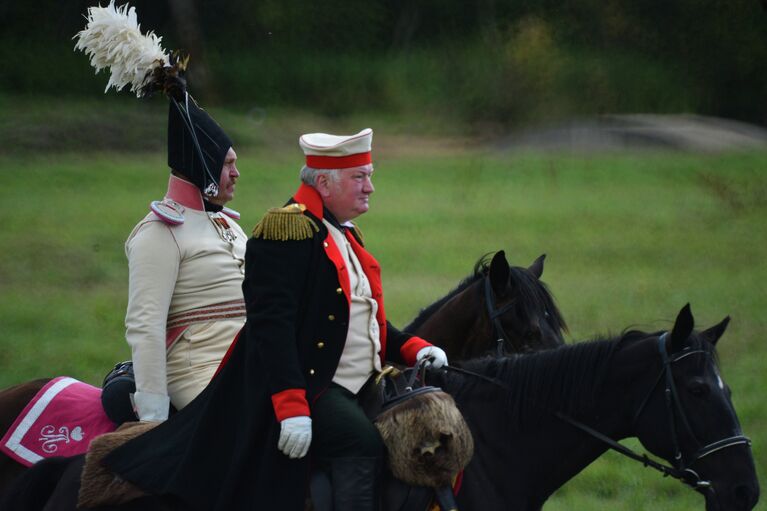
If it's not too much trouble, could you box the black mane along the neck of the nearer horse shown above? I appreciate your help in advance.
[442,331,636,431]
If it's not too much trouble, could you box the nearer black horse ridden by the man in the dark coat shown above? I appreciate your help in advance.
[3,306,759,511]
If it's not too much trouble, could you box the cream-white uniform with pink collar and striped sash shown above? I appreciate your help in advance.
[125,176,247,420]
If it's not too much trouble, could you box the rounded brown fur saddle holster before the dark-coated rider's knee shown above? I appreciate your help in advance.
[374,367,474,488]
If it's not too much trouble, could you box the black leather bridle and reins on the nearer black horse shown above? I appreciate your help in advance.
[442,333,751,490]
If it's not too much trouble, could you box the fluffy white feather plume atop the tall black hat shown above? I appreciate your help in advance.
[75,0,169,96]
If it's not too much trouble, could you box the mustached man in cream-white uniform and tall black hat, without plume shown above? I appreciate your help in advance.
[117,97,247,421]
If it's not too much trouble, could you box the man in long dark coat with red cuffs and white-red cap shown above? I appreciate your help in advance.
[105,129,447,511]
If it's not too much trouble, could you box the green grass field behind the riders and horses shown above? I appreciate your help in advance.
[0,103,767,511]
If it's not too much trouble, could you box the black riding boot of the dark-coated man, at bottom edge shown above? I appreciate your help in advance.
[330,458,381,511]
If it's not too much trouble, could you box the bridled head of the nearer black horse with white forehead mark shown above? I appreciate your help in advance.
[634,304,759,511]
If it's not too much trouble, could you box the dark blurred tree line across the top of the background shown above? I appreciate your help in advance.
[0,0,767,124]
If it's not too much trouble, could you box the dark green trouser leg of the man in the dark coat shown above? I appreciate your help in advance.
[312,383,385,463]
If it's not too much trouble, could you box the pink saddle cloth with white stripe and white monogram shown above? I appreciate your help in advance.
[0,376,117,466]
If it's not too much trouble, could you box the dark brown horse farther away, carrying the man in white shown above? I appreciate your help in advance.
[0,250,567,493]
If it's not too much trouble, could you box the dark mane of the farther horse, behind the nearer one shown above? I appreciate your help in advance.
[404,254,567,332]
